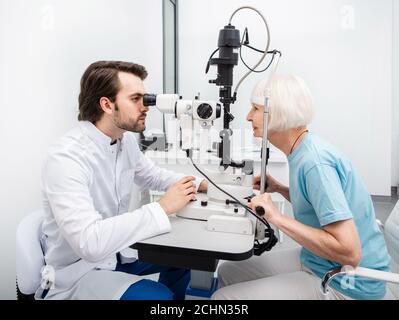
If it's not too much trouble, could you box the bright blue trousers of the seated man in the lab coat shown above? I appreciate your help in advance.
[115,260,190,300]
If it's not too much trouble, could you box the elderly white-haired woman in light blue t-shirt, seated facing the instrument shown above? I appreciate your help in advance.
[213,76,390,300]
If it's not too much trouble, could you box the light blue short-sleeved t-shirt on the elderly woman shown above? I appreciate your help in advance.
[288,133,390,299]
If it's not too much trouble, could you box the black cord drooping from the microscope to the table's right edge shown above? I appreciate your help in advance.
[186,149,278,256]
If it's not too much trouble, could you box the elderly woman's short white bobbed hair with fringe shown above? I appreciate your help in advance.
[251,75,314,131]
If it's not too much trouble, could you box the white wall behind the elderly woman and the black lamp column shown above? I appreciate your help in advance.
[179,0,392,195]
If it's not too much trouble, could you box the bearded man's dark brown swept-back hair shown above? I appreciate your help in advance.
[78,61,147,124]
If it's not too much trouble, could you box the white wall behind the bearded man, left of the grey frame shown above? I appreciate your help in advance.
[0,0,162,299]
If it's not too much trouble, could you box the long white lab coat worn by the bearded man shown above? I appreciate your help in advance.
[36,121,201,299]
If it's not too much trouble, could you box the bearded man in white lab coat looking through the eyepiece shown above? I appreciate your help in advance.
[36,61,207,300]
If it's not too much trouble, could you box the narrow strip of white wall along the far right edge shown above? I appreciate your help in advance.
[392,0,399,186]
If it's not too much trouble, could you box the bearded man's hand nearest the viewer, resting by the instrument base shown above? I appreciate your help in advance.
[158,177,196,215]
